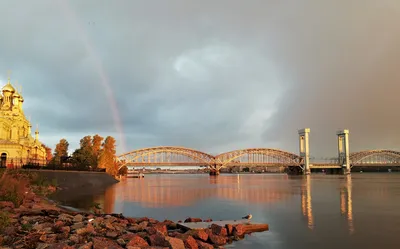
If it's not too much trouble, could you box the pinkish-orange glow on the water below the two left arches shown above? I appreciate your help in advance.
[104,175,295,210]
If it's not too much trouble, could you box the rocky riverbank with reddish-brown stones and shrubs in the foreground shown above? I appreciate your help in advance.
[0,170,268,249]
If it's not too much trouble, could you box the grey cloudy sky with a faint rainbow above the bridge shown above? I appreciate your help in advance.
[0,0,400,156]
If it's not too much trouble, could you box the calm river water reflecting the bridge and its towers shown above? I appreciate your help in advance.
[51,173,400,249]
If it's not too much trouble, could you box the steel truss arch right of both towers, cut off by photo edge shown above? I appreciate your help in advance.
[350,150,400,167]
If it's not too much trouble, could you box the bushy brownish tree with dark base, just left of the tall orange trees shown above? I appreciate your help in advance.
[72,136,93,169]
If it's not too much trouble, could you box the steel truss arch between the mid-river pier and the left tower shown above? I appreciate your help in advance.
[215,148,301,168]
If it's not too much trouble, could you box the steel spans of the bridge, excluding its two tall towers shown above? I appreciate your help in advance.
[118,146,400,170]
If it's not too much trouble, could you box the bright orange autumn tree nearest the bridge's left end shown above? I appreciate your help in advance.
[98,136,118,176]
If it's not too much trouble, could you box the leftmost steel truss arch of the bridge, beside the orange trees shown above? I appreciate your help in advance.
[117,146,215,168]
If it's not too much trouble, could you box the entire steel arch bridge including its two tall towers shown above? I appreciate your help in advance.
[118,129,400,174]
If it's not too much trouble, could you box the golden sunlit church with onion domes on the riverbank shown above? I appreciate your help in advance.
[0,79,46,168]
